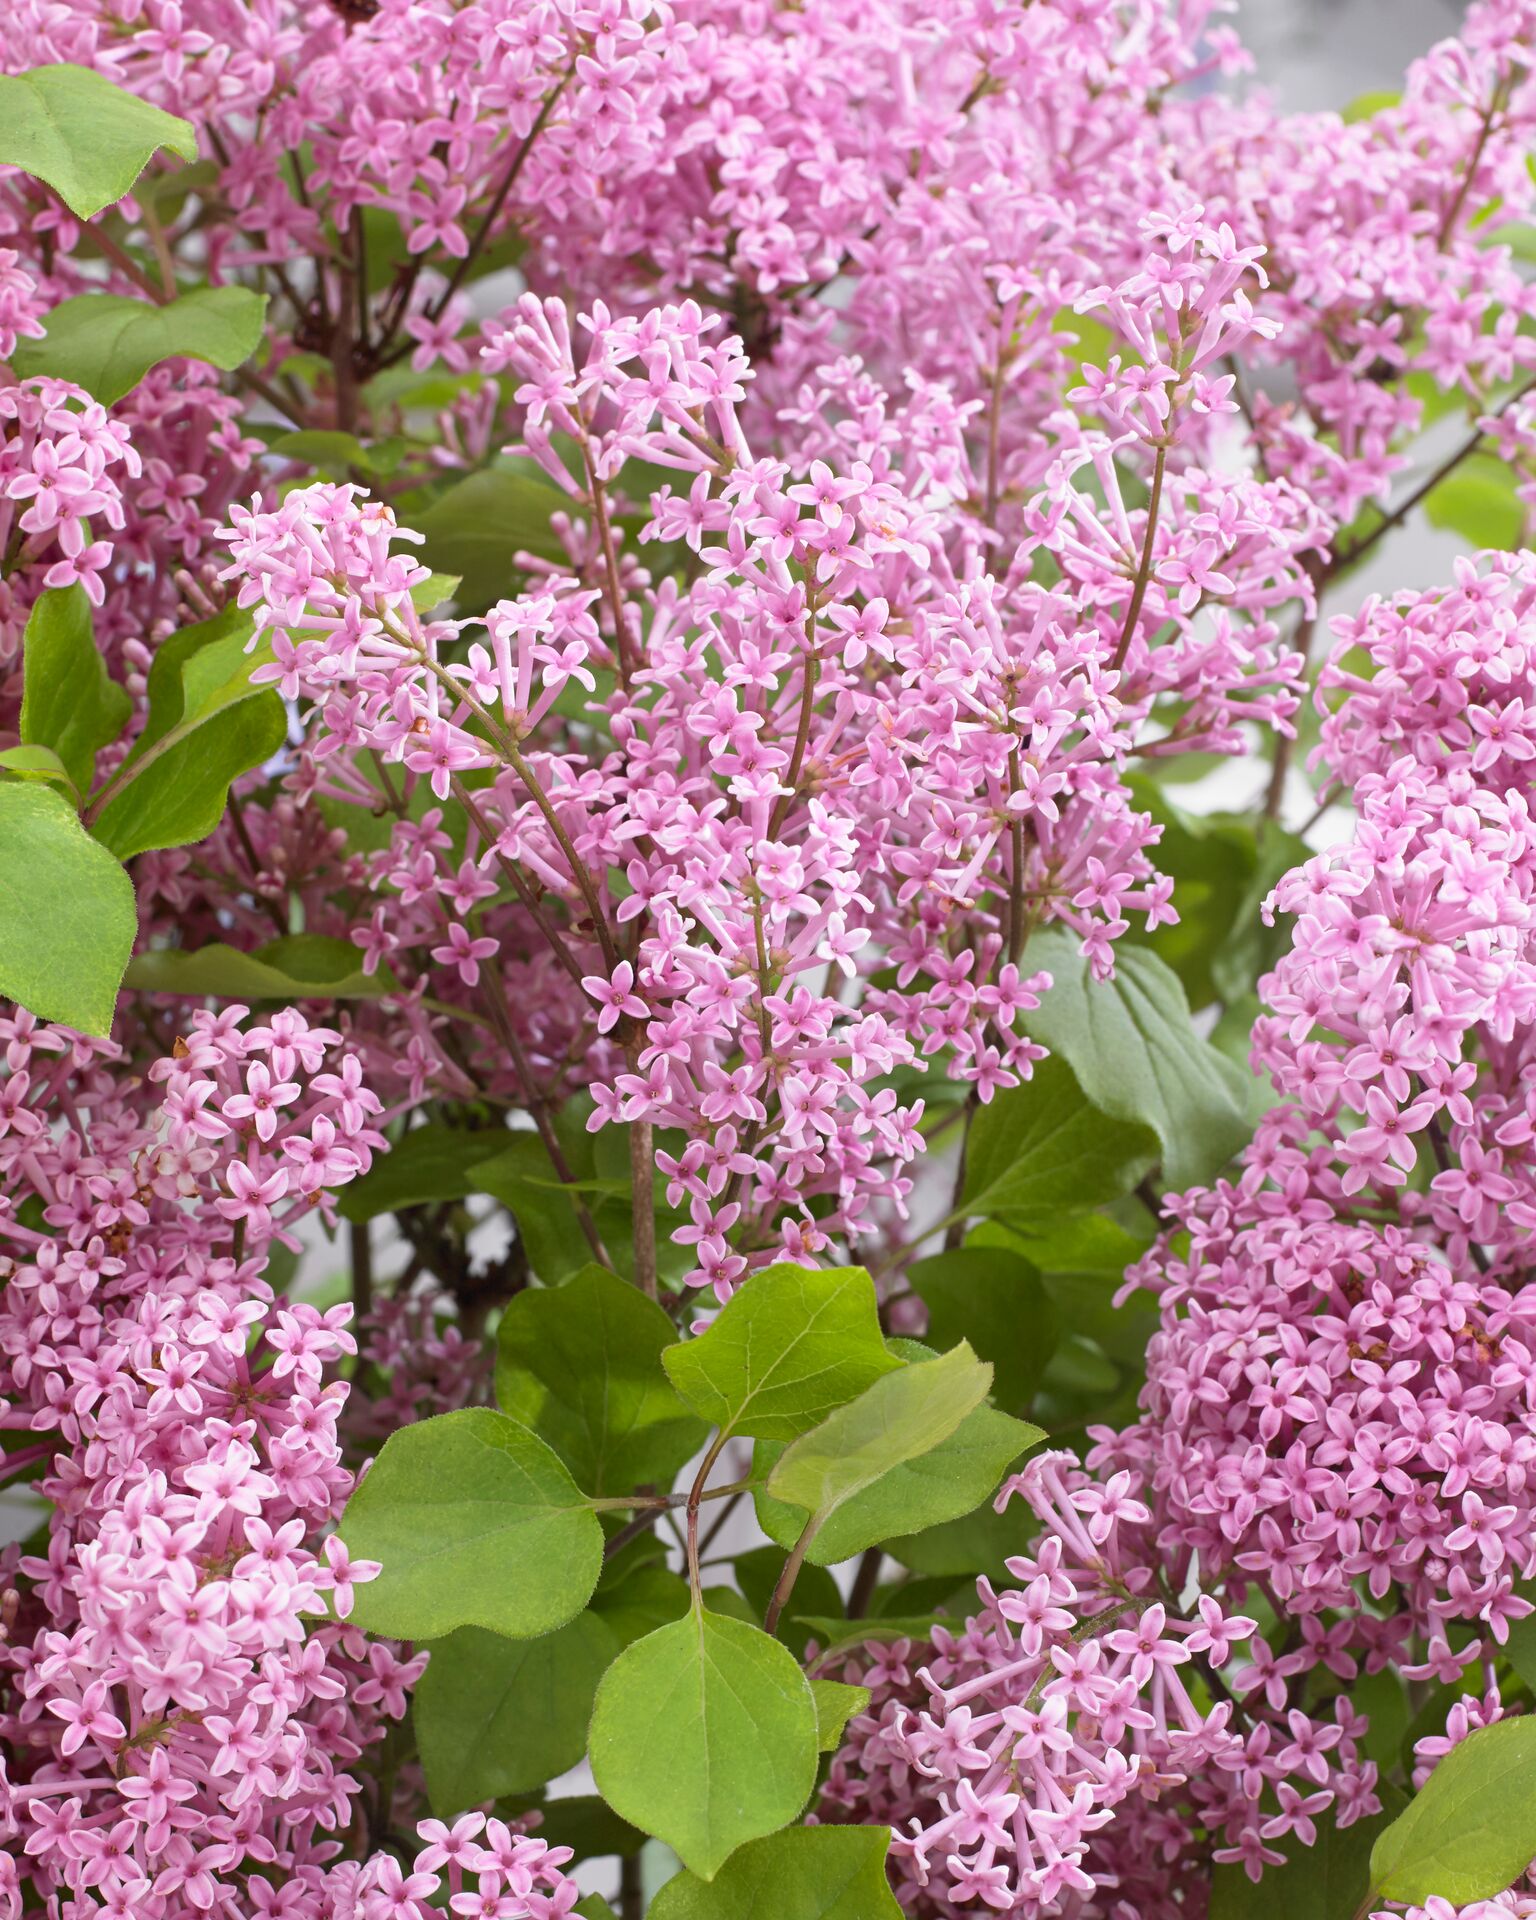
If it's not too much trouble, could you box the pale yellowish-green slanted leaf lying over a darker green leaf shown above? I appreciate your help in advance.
[768,1340,1004,1528]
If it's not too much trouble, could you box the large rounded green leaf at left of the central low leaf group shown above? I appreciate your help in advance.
[342,1407,603,1640]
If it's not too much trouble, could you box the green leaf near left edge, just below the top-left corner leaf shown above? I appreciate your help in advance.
[12,280,267,407]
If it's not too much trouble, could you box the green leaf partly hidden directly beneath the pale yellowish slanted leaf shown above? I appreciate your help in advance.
[755,1407,1041,1572]
